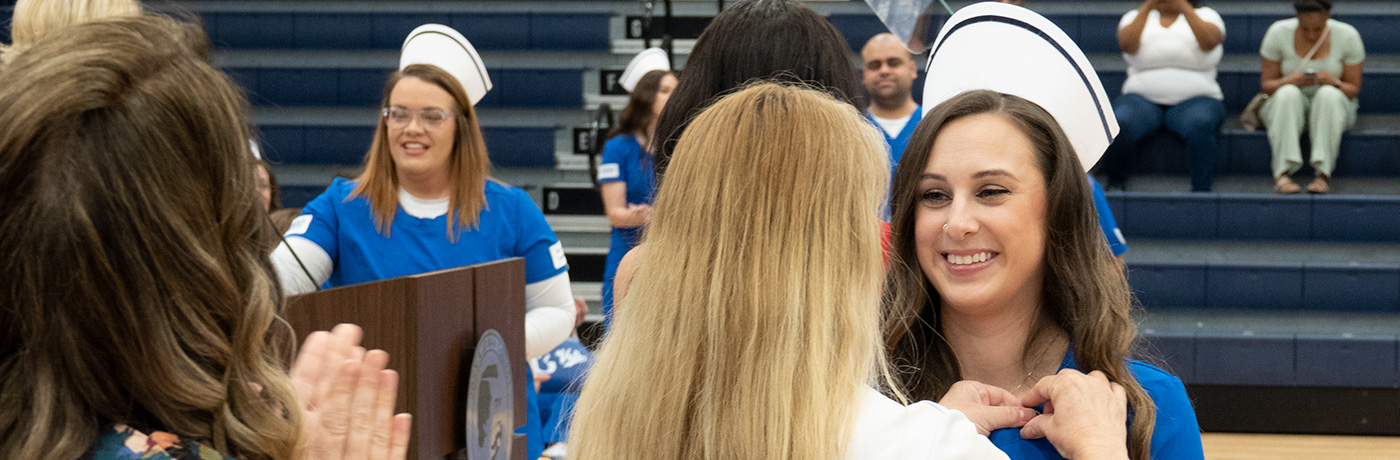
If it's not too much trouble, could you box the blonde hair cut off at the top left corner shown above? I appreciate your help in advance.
[0,0,141,63]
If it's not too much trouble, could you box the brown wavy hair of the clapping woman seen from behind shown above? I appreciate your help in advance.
[0,17,301,460]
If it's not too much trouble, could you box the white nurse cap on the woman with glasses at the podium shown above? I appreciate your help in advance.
[399,24,491,105]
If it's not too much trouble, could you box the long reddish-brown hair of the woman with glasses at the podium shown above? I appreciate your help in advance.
[346,64,491,242]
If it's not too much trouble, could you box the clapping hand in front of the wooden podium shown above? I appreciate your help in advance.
[291,324,413,460]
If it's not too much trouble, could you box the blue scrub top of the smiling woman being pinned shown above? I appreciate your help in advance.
[987,350,1205,460]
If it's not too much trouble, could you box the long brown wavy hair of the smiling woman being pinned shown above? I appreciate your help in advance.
[883,91,1156,460]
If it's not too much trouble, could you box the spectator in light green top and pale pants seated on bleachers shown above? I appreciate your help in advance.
[1259,0,1366,193]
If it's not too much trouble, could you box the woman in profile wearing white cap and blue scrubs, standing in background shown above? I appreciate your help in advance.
[598,48,678,326]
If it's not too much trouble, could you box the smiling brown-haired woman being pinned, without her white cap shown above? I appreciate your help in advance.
[885,91,1201,459]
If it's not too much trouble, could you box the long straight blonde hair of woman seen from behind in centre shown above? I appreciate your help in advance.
[568,82,889,460]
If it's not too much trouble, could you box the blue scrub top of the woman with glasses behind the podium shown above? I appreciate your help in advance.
[287,179,568,287]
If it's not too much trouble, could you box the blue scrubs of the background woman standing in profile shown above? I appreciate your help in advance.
[598,134,657,326]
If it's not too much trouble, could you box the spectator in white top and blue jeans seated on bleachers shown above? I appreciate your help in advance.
[1100,0,1225,192]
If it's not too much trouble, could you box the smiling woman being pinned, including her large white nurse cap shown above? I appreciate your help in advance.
[885,1,1203,460]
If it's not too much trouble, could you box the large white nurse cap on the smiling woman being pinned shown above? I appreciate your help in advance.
[924,1,1119,169]
